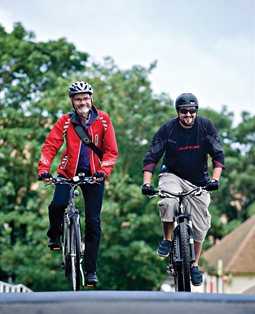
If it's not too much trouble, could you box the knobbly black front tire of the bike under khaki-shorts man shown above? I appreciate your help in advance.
[180,222,191,292]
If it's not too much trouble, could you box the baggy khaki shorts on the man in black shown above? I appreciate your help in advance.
[158,173,211,242]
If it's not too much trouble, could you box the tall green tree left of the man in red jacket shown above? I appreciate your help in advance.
[0,23,88,289]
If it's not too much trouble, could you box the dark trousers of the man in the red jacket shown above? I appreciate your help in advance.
[47,182,104,272]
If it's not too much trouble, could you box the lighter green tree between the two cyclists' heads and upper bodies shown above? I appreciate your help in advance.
[85,58,174,183]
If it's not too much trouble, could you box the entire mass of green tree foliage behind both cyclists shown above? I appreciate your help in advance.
[0,24,255,291]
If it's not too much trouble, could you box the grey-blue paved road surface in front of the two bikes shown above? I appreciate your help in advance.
[0,291,255,314]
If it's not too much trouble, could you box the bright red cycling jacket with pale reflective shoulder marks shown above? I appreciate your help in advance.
[38,106,118,178]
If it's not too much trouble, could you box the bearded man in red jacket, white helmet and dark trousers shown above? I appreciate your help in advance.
[38,81,118,284]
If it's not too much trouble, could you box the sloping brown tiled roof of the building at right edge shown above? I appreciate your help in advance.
[202,215,255,274]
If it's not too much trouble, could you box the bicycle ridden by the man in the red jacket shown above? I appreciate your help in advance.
[46,173,98,291]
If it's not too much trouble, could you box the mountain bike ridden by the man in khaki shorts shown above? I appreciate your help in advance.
[150,187,206,292]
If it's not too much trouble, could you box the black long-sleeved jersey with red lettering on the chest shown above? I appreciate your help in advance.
[143,116,224,186]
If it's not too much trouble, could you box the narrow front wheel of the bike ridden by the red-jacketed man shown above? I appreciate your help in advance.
[70,221,81,291]
